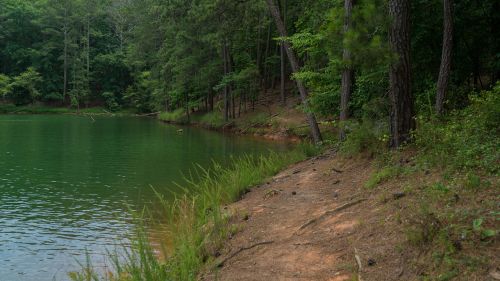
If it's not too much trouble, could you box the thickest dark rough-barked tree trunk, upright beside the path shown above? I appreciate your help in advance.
[389,0,415,148]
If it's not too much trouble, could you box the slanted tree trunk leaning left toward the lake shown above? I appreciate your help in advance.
[266,0,322,143]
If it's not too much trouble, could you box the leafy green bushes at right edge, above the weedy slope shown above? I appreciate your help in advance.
[414,85,500,174]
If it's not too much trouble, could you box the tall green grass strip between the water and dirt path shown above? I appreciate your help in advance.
[70,145,319,281]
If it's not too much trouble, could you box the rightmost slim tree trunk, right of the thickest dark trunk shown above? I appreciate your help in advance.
[436,0,453,115]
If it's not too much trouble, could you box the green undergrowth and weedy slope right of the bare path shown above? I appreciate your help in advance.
[340,84,500,280]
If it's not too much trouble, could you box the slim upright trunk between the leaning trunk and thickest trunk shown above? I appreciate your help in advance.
[339,0,354,141]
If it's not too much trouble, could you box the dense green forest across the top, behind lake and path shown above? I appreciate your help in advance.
[0,0,500,146]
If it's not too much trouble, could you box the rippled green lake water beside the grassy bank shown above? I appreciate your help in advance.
[0,115,287,281]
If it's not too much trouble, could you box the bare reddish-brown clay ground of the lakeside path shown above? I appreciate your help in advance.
[200,152,498,281]
